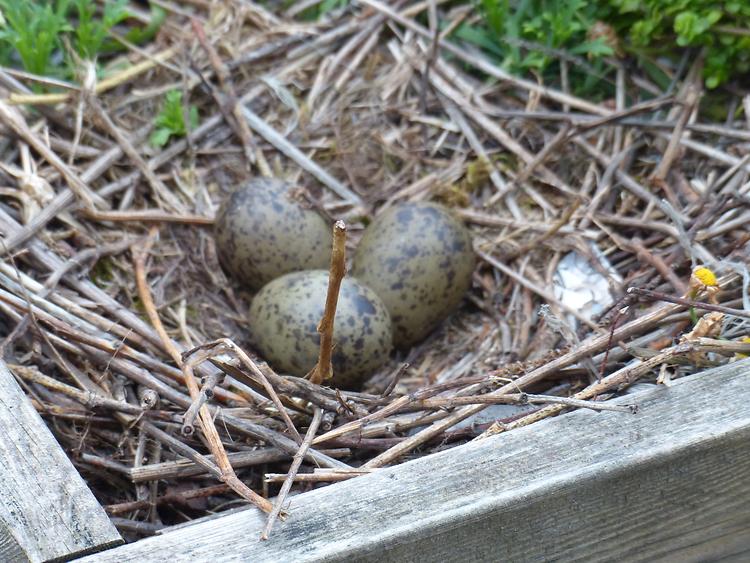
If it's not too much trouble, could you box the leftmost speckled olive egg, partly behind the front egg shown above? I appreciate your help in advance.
[214,178,333,289]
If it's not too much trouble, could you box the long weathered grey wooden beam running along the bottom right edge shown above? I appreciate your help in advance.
[84,360,750,563]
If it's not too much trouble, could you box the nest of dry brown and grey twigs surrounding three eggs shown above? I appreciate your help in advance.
[0,2,750,539]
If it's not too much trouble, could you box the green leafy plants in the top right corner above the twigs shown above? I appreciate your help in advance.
[470,0,750,94]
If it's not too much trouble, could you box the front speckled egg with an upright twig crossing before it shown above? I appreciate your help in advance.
[250,270,391,389]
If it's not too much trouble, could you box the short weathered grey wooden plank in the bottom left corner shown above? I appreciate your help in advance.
[0,361,122,561]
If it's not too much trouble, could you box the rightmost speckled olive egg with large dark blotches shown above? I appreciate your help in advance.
[352,203,474,348]
